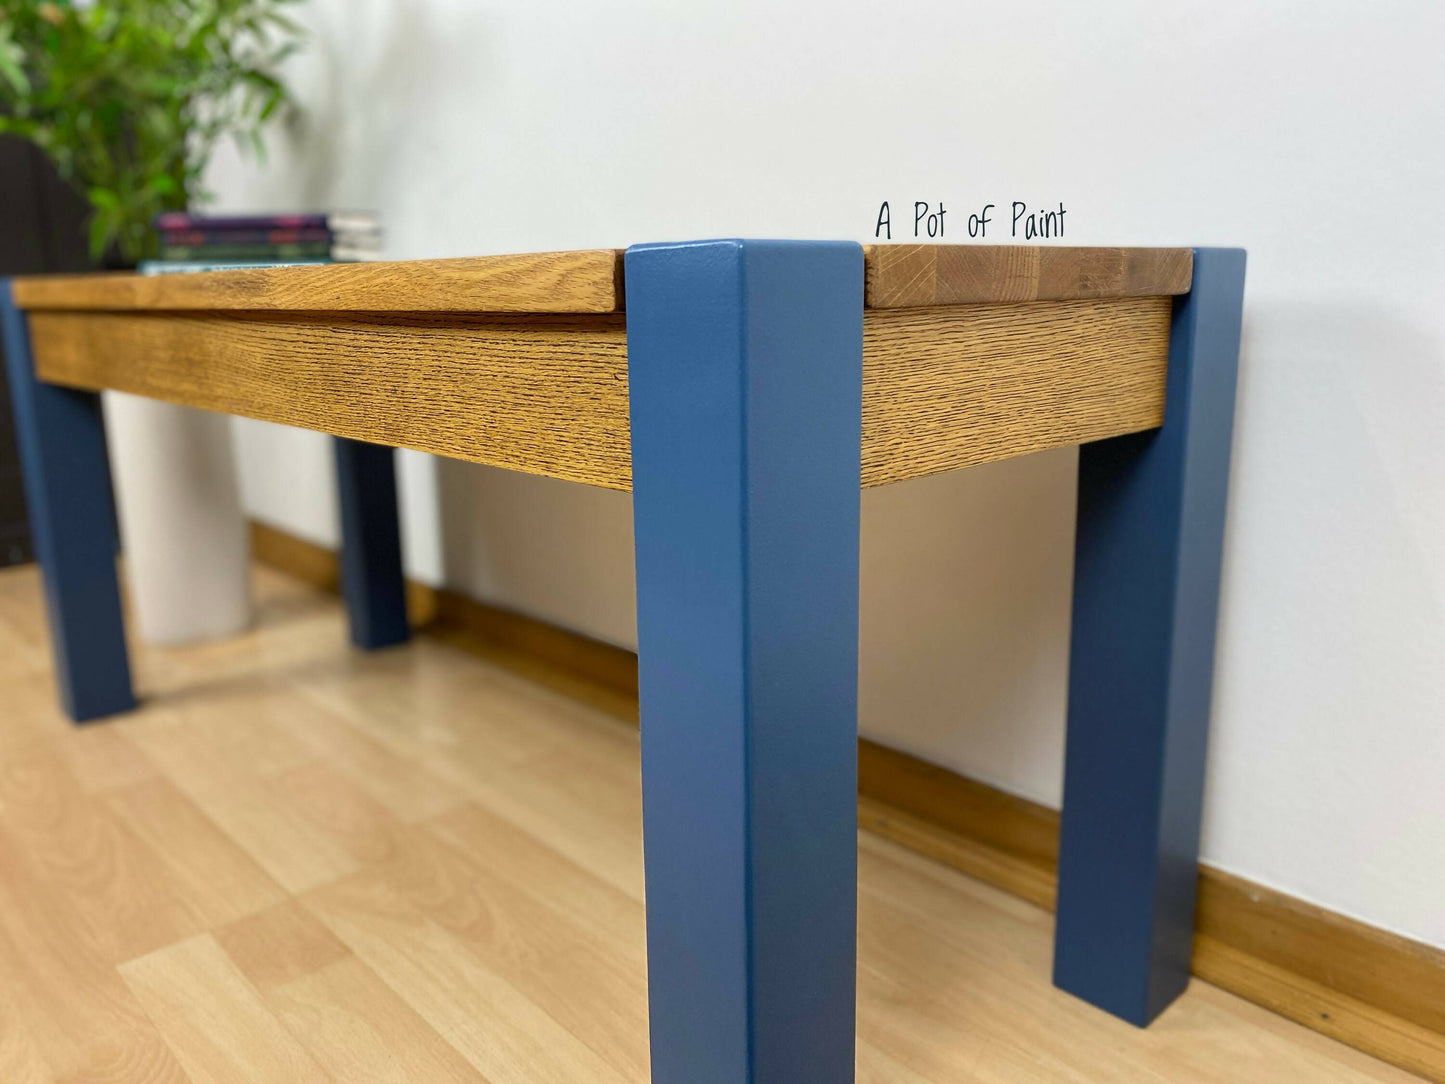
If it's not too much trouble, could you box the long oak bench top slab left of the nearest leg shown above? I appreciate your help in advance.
[14,249,623,312]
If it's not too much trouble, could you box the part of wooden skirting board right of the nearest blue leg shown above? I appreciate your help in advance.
[858,740,1445,1081]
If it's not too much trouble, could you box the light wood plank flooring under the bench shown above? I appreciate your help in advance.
[0,568,1415,1084]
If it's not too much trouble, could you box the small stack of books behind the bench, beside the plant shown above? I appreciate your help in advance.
[145,211,381,272]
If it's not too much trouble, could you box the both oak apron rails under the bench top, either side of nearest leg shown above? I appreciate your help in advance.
[30,298,1169,490]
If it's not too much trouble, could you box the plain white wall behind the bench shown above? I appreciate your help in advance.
[212,0,1445,945]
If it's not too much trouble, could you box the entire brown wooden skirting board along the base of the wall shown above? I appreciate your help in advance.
[251,523,1445,1084]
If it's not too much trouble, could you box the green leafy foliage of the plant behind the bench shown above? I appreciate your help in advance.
[0,0,299,266]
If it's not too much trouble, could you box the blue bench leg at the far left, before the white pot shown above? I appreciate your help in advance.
[0,280,136,723]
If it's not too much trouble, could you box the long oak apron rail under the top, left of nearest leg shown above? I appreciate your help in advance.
[30,312,631,489]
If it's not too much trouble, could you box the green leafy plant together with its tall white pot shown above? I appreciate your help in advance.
[0,0,299,643]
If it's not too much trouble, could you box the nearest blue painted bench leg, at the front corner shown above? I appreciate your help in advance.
[626,241,863,1084]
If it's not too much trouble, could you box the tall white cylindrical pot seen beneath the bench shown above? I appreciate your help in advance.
[104,392,251,645]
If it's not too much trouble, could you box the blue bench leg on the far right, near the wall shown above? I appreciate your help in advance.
[1053,249,1244,1026]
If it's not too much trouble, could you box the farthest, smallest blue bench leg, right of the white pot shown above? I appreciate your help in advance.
[335,436,410,650]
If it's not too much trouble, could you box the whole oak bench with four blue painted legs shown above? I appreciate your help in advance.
[3,241,1244,1083]
